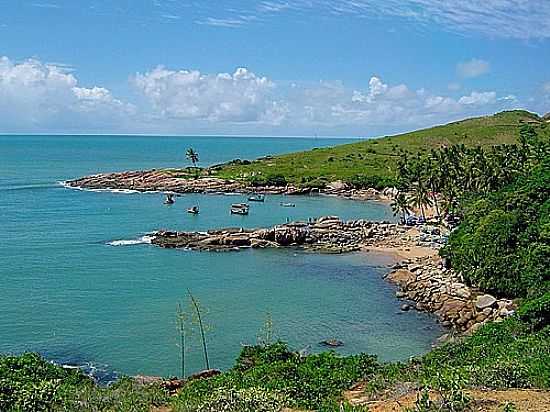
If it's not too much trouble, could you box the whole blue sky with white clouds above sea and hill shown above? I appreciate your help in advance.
[0,0,550,137]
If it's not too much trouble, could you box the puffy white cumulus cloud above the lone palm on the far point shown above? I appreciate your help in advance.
[134,67,287,124]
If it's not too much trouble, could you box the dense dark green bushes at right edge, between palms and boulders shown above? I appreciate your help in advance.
[441,162,550,297]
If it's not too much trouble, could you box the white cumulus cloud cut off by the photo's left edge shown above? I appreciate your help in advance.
[0,57,133,129]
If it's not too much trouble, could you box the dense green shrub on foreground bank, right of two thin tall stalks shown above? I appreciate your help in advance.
[177,343,378,410]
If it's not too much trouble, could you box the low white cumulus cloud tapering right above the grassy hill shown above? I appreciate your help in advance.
[280,76,512,129]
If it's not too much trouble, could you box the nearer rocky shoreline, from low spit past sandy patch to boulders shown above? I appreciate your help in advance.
[151,216,516,343]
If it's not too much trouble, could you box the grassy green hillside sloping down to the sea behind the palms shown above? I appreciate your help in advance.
[211,110,550,186]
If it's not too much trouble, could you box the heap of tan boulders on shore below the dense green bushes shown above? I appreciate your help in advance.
[387,256,515,334]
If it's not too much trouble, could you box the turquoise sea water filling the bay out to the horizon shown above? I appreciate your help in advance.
[0,136,440,375]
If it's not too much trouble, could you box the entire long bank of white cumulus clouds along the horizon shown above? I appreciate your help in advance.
[0,57,528,134]
